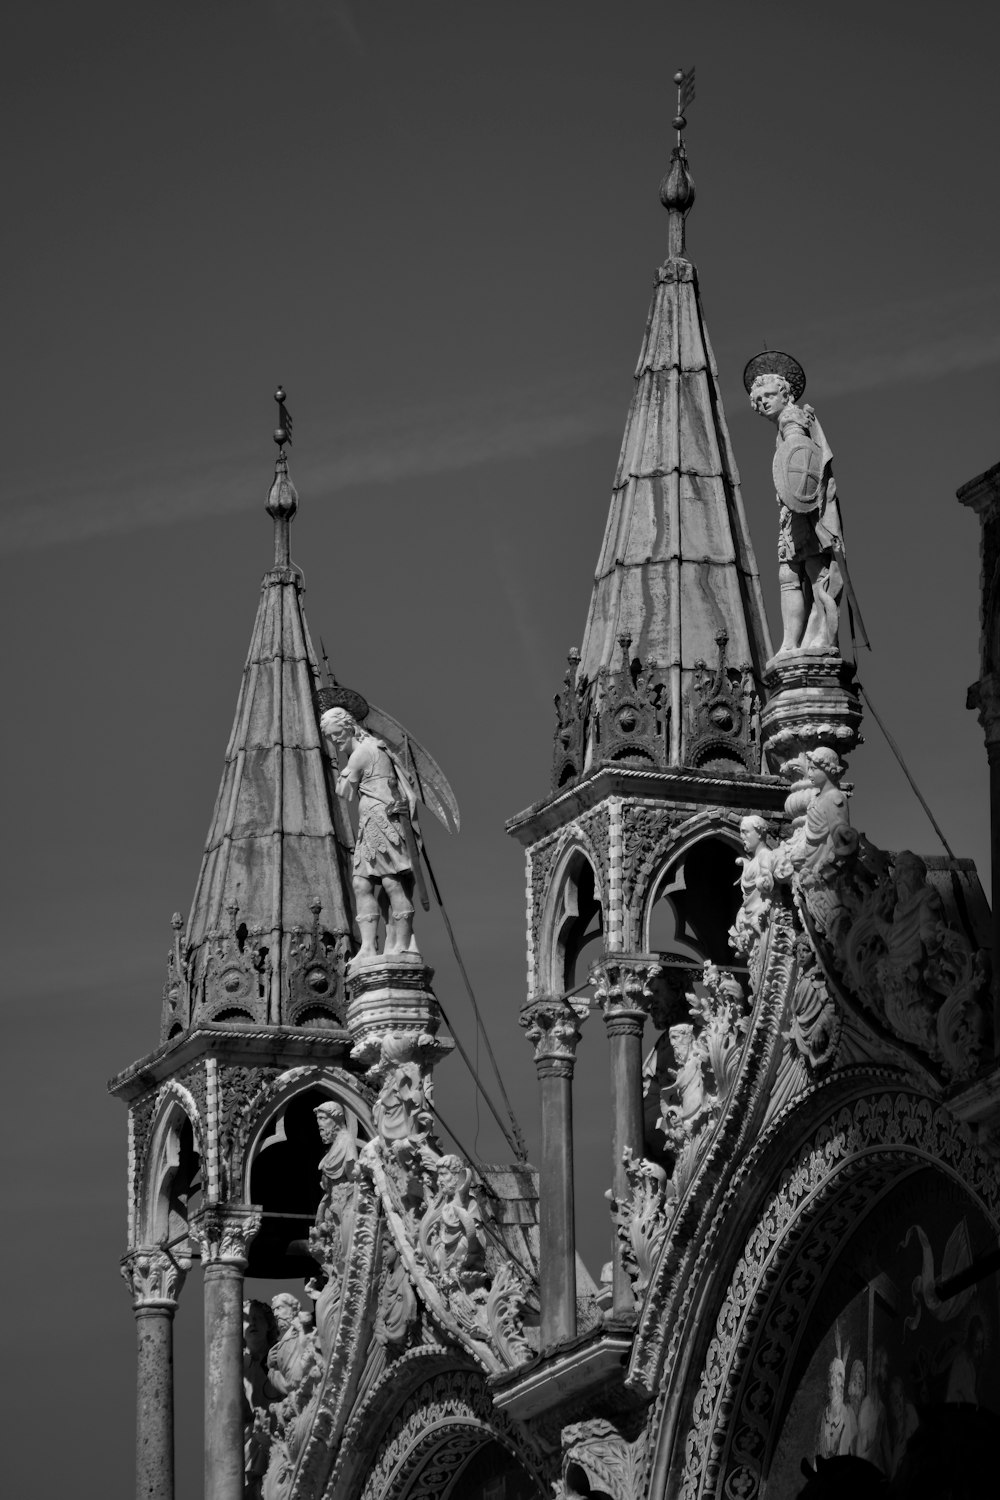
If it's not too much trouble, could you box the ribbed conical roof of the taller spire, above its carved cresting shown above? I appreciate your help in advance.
[576,146,772,765]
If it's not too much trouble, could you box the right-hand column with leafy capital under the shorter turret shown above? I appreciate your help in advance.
[193,1203,261,1500]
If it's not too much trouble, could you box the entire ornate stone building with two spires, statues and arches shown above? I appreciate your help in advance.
[111,111,1000,1500]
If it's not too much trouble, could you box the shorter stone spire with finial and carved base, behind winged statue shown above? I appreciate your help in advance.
[163,387,351,1037]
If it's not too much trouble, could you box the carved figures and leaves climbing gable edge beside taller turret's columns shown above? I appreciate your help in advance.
[609,963,750,1298]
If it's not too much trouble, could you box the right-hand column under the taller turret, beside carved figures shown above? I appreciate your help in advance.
[591,954,663,1319]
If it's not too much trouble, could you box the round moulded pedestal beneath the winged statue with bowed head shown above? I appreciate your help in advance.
[345,953,454,1062]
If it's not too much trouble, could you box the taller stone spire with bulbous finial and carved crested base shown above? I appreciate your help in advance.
[553,110,772,786]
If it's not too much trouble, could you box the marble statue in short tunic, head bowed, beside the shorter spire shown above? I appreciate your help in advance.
[319,708,420,959]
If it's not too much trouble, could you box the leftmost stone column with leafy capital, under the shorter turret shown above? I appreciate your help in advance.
[121,1245,190,1500]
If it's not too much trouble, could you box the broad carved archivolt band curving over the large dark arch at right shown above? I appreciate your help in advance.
[665,1080,1000,1500]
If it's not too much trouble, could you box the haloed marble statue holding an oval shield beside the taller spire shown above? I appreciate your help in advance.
[744,351,846,656]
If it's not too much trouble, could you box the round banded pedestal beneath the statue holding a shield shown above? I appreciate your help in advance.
[760,651,862,774]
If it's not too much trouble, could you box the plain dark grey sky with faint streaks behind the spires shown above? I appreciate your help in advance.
[0,0,1000,1500]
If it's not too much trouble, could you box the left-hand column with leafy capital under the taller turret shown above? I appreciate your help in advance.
[520,998,589,1352]
